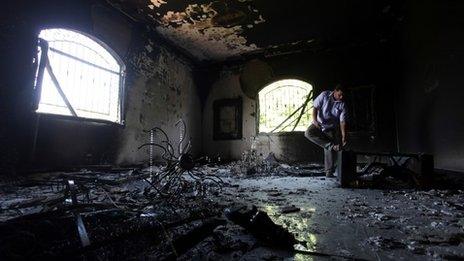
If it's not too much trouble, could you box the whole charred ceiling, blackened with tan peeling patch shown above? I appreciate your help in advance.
[107,0,401,62]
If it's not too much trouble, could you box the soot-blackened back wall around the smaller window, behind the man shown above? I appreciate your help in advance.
[203,42,395,162]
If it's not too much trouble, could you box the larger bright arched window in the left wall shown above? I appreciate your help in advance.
[36,29,124,123]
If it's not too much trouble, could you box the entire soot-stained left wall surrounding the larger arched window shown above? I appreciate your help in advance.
[0,0,201,172]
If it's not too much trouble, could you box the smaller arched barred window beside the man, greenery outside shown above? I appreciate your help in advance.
[258,79,313,132]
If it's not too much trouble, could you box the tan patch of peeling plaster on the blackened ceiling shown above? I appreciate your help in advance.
[156,2,265,60]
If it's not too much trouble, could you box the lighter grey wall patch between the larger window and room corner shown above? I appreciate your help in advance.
[116,46,201,164]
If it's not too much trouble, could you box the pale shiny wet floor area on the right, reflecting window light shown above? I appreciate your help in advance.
[220,177,464,260]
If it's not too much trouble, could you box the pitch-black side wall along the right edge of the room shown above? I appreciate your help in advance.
[397,1,464,171]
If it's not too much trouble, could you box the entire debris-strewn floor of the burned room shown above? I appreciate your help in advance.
[0,163,464,260]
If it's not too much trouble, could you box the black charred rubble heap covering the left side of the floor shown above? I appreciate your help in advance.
[0,164,320,260]
